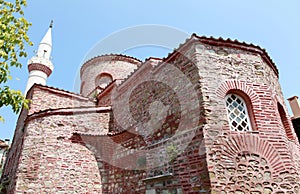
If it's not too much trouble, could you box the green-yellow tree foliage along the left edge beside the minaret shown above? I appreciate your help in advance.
[0,0,32,121]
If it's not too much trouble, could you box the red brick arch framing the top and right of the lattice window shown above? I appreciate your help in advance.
[216,80,259,131]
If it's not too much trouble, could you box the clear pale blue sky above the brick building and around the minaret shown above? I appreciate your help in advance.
[0,0,300,139]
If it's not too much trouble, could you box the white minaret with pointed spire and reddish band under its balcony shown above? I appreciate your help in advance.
[25,21,53,94]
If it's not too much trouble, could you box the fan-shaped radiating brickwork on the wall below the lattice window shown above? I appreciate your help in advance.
[210,133,300,193]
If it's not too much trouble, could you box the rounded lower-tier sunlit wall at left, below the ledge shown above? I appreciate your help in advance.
[12,113,109,193]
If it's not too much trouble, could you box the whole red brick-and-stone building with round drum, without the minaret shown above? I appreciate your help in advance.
[2,35,300,194]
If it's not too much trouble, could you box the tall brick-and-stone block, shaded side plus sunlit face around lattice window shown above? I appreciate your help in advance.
[74,39,299,193]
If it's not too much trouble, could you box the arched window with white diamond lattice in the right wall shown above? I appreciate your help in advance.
[225,93,252,131]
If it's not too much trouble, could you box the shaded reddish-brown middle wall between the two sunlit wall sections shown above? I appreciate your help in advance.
[108,50,210,193]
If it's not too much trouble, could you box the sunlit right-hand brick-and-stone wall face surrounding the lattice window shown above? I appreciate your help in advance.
[194,41,300,193]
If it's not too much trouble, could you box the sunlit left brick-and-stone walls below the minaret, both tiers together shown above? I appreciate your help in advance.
[4,85,104,193]
